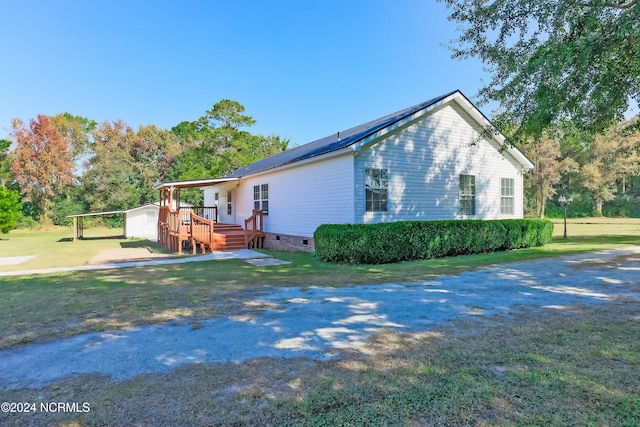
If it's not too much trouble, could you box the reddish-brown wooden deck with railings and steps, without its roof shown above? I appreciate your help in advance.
[158,207,265,254]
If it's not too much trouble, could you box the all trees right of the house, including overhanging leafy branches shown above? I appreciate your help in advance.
[439,0,640,217]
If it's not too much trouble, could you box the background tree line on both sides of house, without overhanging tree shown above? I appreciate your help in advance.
[0,100,640,232]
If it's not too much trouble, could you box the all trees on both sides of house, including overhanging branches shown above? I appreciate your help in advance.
[0,0,640,232]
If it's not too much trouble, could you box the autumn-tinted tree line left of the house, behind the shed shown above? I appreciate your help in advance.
[0,99,289,233]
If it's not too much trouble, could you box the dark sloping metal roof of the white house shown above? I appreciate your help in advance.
[225,90,464,178]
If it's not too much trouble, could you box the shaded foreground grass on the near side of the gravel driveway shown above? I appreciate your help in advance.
[0,301,640,427]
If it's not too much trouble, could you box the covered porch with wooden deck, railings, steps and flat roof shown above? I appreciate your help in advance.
[156,179,265,254]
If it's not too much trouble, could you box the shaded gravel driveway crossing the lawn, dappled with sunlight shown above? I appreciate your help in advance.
[0,247,640,389]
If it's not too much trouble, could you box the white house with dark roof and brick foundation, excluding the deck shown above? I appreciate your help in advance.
[158,91,533,249]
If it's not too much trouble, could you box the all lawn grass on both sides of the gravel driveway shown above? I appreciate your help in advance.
[0,219,640,427]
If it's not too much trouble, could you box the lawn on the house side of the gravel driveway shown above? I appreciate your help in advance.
[0,220,640,348]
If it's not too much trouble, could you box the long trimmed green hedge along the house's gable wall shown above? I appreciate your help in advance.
[313,219,553,264]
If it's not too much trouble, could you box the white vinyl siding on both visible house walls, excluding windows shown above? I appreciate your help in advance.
[205,97,523,237]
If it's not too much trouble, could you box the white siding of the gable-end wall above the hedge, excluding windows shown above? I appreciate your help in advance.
[354,103,522,223]
